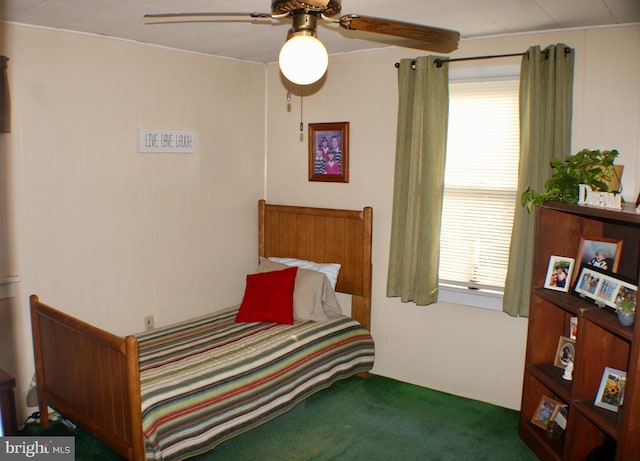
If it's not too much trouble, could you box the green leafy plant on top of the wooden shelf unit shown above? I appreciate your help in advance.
[521,149,619,212]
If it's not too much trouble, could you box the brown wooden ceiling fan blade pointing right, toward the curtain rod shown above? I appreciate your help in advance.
[336,14,460,53]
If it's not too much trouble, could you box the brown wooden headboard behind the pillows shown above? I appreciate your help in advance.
[258,200,373,330]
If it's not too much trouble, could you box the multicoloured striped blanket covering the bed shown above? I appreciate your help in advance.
[138,307,374,460]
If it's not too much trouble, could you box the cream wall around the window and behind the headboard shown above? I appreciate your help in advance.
[267,26,640,408]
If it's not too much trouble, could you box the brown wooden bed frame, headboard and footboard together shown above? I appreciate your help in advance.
[30,200,372,460]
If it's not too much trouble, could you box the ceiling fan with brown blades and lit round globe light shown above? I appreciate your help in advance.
[144,0,460,85]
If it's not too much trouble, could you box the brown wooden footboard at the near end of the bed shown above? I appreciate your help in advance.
[30,295,144,460]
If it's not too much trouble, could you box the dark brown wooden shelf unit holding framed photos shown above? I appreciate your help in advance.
[519,202,640,461]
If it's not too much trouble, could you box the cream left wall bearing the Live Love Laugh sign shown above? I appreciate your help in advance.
[0,25,265,420]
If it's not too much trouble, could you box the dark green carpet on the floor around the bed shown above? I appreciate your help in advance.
[23,375,537,461]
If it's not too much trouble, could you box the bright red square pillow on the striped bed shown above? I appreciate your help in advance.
[236,267,298,325]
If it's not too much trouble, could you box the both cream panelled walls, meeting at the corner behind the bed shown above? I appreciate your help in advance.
[0,20,640,420]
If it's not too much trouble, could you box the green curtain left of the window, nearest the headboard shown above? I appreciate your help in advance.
[387,56,449,306]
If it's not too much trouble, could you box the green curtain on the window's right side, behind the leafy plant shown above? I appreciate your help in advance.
[503,44,575,317]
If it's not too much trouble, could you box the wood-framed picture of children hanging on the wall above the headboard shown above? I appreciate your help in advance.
[309,122,349,182]
